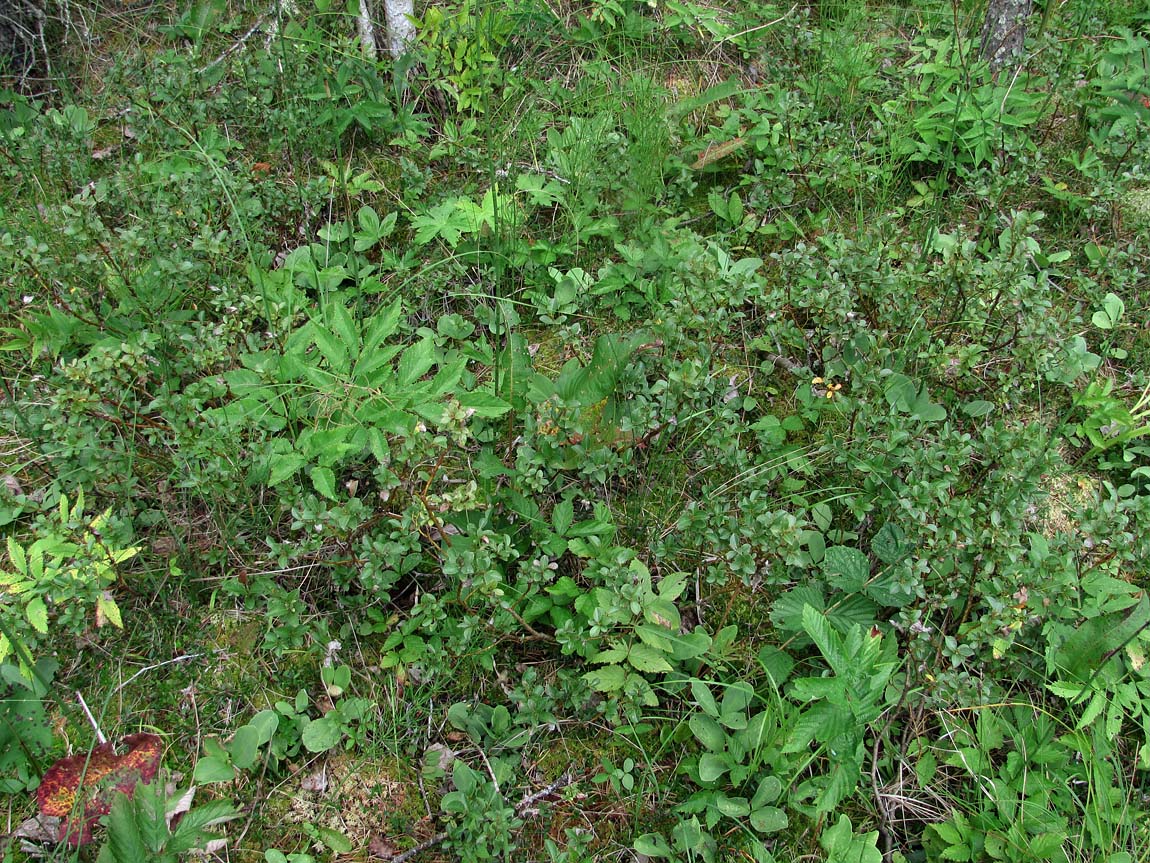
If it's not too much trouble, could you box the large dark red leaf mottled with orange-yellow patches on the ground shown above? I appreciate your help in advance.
[36,734,163,846]
